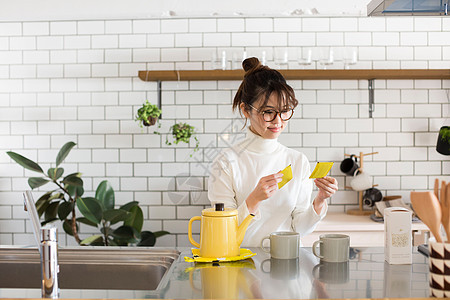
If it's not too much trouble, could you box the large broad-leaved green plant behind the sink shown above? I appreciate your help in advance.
[7,142,169,246]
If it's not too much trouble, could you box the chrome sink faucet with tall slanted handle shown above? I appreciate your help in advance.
[23,191,59,299]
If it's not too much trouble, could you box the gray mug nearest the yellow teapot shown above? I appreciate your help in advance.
[261,231,300,259]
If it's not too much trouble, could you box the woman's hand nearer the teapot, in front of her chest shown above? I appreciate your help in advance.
[246,172,283,213]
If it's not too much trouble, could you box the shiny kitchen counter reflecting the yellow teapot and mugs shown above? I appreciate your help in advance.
[0,247,429,299]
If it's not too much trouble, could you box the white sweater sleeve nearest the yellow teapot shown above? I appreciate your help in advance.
[208,154,260,224]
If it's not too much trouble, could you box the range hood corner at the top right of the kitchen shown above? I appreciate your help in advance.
[367,0,450,16]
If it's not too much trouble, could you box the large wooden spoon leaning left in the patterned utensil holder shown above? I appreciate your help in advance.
[411,192,442,243]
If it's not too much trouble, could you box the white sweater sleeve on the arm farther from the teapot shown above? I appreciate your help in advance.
[291,158,328,236]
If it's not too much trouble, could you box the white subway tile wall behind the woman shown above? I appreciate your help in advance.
[0,17,450,246]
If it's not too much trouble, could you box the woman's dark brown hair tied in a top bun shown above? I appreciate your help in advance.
[233,57,298,116]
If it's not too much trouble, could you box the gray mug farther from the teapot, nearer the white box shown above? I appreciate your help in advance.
[312,233,350,262]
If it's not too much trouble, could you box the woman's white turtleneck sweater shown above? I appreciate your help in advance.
[208,129,327,247]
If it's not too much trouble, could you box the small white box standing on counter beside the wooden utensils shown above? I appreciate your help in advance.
[384,207,412,265]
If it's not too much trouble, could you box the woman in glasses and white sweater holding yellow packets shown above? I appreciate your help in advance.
[208,57,338,247]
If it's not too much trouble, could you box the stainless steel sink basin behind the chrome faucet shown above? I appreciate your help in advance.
[0,247,179,291]
